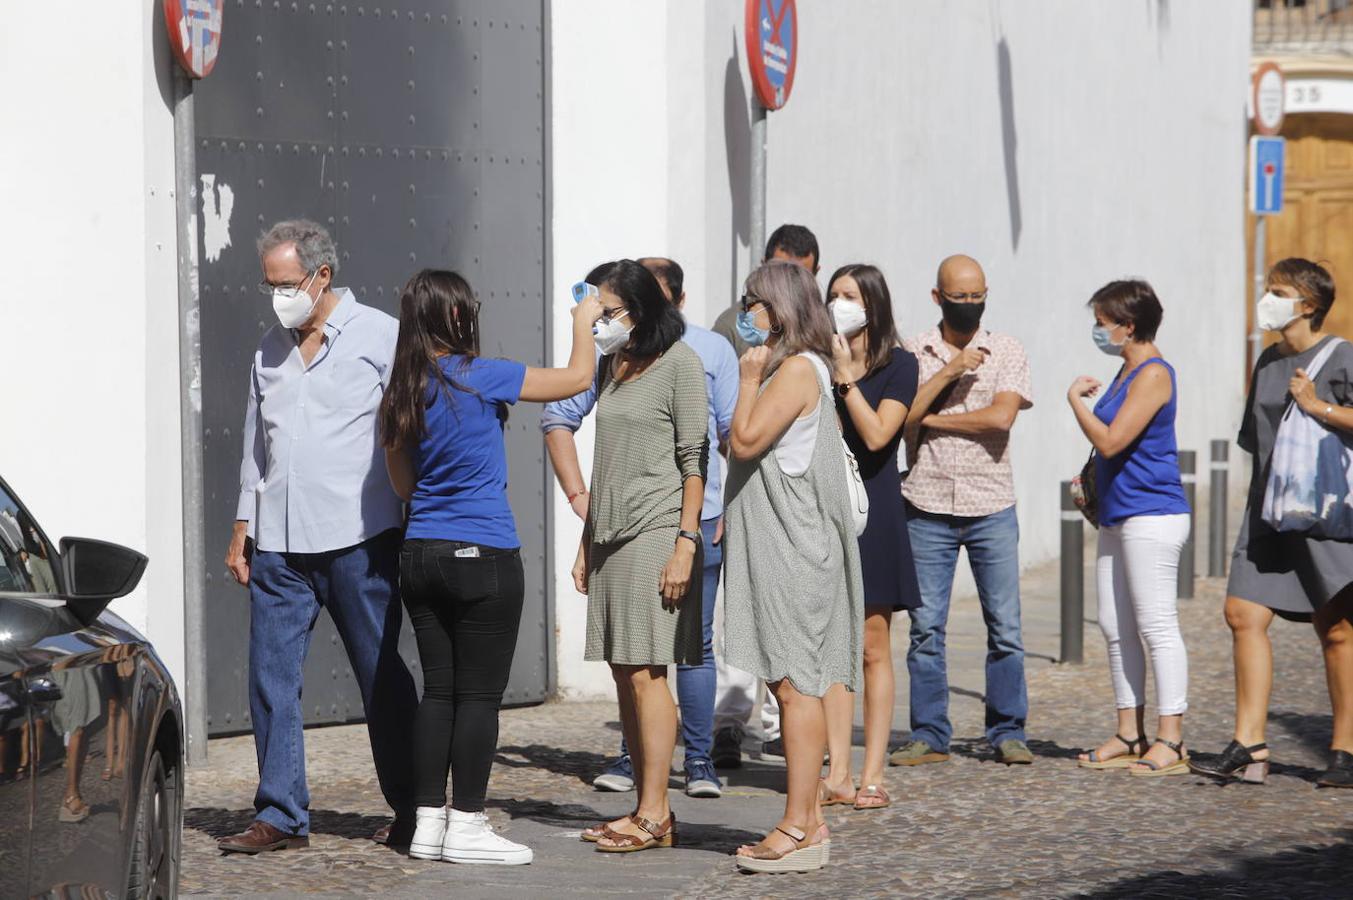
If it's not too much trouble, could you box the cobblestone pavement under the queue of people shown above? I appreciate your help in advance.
[183,564,1353,897]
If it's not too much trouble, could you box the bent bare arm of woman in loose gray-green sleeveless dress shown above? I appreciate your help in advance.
[728,348,817,460]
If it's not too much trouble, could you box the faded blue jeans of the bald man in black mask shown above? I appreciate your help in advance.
[907,505,1028,751]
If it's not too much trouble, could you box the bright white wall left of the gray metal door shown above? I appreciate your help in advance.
[0,3,184,689]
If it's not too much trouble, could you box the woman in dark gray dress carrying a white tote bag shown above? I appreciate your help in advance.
[1191,258,1353,788]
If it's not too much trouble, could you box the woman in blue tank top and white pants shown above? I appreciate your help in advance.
[1066,282,1189,775]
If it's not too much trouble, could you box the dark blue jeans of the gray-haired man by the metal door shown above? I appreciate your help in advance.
[249,529,418,835]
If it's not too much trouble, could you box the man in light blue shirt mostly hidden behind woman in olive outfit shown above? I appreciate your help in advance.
[540,257,737,797]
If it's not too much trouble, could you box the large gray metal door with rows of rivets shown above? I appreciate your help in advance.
[196,0,553,734]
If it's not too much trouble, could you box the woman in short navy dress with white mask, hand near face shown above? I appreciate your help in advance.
[820,264,920,809]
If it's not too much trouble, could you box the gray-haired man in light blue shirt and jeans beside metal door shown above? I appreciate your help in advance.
[219,221,418,853]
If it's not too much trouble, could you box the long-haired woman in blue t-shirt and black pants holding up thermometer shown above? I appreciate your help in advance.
[380,269,602,865]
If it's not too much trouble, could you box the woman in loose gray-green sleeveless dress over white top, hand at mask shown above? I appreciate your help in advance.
[724,261,865,872]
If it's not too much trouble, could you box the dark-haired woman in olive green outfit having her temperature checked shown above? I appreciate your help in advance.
[574,260,709,853]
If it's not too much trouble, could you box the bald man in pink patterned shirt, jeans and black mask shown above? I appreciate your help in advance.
[889,256,1034,766]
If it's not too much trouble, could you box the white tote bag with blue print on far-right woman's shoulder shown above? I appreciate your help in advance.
[1261,338,1353,540]
